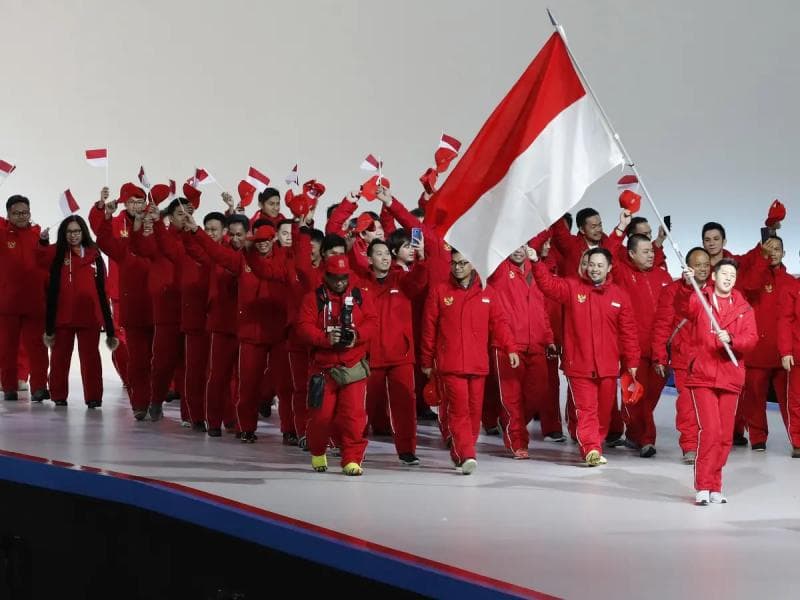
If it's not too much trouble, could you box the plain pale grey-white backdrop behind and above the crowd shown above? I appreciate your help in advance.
[0,0,800,271]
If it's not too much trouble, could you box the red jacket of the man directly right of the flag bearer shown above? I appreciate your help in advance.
[736,257,794,369]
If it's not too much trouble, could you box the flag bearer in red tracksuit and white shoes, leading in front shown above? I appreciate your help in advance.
[675,258,758,505]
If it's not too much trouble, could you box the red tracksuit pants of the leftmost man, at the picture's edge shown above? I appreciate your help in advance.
[0,315,47,392]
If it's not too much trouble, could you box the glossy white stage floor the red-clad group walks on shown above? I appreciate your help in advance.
[0,366,800,600]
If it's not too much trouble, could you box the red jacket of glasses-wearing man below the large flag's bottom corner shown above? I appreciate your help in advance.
[420,273,516,375]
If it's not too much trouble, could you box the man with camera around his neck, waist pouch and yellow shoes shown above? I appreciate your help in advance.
[297,255,377,475]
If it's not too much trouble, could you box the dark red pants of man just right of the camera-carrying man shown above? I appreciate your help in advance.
[367,364,417,454]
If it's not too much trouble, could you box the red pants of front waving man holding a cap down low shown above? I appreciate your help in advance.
[567,377,617,456]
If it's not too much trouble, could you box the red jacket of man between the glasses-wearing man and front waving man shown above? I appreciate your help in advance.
[488,258,554,354]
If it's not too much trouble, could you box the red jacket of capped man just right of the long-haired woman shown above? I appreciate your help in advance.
[89,206,153,327]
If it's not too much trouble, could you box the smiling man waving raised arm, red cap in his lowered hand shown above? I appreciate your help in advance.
[531,248,640,467]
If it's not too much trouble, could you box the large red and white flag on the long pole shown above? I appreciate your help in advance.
[425,33,624,277]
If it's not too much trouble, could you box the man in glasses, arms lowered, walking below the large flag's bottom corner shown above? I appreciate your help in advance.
[420,249,519,475]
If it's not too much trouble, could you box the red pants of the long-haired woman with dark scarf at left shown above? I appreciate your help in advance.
[50,327,103,404]
